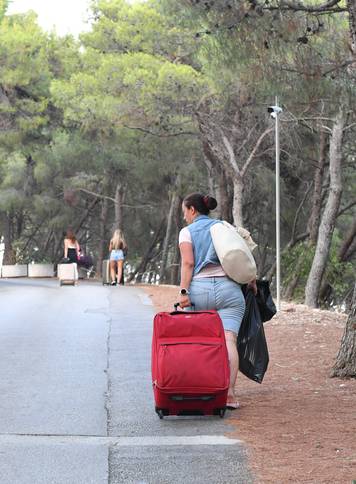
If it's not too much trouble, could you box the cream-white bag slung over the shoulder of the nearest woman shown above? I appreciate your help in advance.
[210,222,257,284]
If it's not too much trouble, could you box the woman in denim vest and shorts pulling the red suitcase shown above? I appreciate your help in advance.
[179,193,255,409]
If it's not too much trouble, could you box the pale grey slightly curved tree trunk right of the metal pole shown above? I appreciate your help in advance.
[305,109,346,308]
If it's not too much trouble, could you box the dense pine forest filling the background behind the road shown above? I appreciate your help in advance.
[0,0,356,307]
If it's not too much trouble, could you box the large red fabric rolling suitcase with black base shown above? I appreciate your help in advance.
[151,311,230,418]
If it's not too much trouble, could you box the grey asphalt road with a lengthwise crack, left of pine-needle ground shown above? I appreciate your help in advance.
[0,279,254,484]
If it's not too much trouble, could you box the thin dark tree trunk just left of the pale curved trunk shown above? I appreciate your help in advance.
[308,131,327,245]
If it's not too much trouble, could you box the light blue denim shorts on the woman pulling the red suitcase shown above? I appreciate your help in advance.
[189,277,245,334]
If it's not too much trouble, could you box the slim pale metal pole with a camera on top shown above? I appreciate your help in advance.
[267,97,282,311]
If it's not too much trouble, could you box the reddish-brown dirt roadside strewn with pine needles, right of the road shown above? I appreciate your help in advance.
[143,286,356,484]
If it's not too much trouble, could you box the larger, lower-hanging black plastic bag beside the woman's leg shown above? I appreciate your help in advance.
[237,290,269,383]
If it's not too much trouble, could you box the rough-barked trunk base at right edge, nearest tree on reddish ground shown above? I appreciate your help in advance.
[331,283,356,378]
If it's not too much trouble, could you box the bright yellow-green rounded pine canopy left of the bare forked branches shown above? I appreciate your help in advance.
[51,53,206,131]
